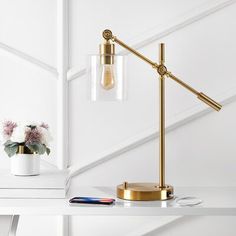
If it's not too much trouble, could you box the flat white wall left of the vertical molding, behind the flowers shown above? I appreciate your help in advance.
[0,0,56,166]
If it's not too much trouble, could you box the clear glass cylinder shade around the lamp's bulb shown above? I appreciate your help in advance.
[89,55,126,101]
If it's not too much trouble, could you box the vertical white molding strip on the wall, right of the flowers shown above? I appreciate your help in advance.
[57,0,69,169]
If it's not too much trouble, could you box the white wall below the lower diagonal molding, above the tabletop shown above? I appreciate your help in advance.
[72,102,236,188]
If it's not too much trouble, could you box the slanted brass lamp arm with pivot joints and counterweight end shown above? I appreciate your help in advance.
[103,30,222,111]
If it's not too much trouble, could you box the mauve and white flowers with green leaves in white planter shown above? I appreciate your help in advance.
[2,121,52,157]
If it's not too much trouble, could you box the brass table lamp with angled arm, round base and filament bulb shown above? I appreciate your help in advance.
[91,30,222,201]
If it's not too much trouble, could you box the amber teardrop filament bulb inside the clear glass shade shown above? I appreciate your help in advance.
[101,64,115,90]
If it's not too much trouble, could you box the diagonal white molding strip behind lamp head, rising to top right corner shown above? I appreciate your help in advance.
[67,0,236,80]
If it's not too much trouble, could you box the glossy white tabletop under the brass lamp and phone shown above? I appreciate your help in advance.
[0,187,236,216]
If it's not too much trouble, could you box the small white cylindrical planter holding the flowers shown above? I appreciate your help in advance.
[11,154,40,176]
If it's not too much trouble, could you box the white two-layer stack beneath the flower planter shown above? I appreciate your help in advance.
[0,161,69,198]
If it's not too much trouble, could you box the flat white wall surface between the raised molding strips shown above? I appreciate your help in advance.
[0,0,236,236]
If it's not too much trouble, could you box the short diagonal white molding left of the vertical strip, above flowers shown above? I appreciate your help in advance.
[0,43,57,76]
